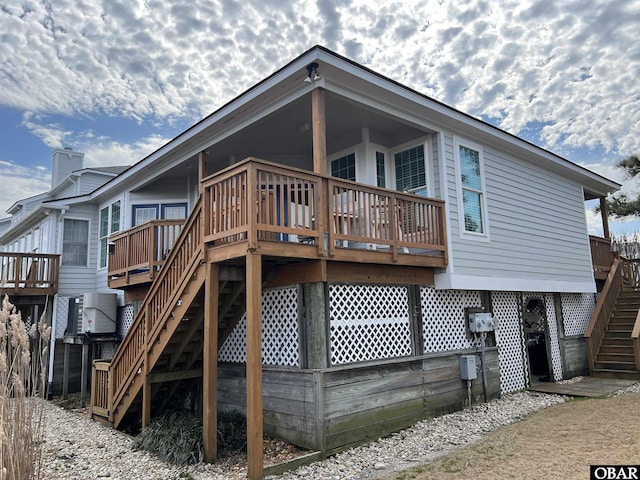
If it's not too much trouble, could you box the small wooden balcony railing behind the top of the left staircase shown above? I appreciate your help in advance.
[108,220,185,284]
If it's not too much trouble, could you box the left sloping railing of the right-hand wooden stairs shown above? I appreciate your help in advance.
[584,257,623,371]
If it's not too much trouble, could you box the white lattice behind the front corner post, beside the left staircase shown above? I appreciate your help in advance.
[218,287,300,367]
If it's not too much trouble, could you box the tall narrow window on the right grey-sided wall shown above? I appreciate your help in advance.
[456,140,487,234]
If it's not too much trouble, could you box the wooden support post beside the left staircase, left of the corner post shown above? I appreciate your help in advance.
[202,263,220,462]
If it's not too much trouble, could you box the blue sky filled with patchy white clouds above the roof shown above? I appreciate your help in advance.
[0,0,640,230]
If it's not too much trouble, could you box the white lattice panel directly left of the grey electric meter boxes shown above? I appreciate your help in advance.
[420,287,482,352]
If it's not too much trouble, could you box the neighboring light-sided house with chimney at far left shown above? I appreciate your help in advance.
[0,148,128,394]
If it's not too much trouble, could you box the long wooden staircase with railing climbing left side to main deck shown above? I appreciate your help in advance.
[91,197,255,430]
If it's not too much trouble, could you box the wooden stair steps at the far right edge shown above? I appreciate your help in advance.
[591,289,640,380]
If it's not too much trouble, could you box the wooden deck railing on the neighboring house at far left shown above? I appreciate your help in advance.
[0,252,60,295]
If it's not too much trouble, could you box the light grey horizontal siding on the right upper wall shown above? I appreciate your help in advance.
[437,135,595,291]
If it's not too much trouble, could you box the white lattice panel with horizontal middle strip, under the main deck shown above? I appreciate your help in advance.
[329,285,412,365]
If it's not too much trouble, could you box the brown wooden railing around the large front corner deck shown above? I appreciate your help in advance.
[202,158,447,264]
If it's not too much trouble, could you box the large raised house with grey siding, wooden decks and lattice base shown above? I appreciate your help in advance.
[0,46,640,478]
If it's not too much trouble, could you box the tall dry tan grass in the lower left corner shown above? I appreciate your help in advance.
[0,296,51,480]
